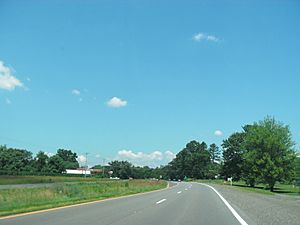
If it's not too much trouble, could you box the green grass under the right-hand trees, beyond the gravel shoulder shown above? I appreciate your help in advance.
[197,180,300,196]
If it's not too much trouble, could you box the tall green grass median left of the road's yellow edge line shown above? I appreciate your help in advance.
[0,180,167,216]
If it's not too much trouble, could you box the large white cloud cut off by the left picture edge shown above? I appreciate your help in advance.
[0,61,23,91]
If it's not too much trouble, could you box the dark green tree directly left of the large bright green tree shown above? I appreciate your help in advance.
[222,132,245,181]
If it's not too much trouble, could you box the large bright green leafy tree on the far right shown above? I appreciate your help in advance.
[243,117,295,191]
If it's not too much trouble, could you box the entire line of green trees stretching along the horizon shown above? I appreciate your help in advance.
[0,117,300,191]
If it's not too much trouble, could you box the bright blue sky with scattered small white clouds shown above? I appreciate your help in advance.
[0,0,300,167]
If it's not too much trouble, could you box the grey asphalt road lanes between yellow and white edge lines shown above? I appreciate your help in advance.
[0,182,247,225]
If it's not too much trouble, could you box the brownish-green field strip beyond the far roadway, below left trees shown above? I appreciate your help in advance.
[0,176,100,185]
